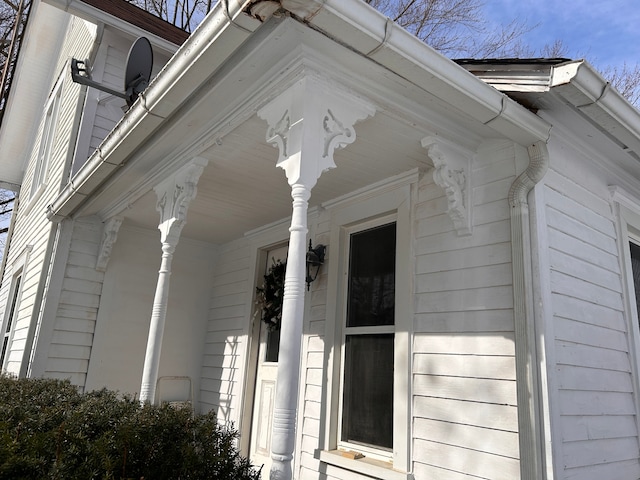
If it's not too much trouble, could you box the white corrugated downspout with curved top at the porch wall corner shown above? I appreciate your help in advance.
[509,141,549,480]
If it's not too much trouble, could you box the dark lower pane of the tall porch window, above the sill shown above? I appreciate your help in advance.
[342,333,393,449]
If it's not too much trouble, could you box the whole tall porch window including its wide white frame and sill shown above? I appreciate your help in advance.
[319,181,417,480]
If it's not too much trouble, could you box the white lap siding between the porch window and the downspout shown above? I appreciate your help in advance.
[412,142,520,480]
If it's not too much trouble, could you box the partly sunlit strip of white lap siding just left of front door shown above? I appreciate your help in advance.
[200,241,253,425]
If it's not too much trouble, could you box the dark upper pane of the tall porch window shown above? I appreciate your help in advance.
[347,223,396,327]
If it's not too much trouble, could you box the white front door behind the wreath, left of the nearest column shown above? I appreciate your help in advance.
[249,246,287,479]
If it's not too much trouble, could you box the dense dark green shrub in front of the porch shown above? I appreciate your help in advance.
[0,376,259,480]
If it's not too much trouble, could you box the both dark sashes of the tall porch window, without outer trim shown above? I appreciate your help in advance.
[340,222,396,452]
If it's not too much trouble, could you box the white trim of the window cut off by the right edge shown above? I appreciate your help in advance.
[609,186,640,442]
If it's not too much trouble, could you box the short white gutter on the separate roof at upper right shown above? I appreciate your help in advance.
[550,60,640,160]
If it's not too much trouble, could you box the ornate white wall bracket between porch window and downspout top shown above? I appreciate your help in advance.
[422,137,473,236]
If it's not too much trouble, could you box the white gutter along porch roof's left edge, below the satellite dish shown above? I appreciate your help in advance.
[47,0,260,221]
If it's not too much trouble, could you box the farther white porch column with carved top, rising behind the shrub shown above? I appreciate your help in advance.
[140,158,207,403]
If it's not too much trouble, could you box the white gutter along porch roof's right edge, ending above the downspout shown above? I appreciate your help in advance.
[281,0,551,146]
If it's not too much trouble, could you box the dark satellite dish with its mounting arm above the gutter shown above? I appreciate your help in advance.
[71,37,153,107]
